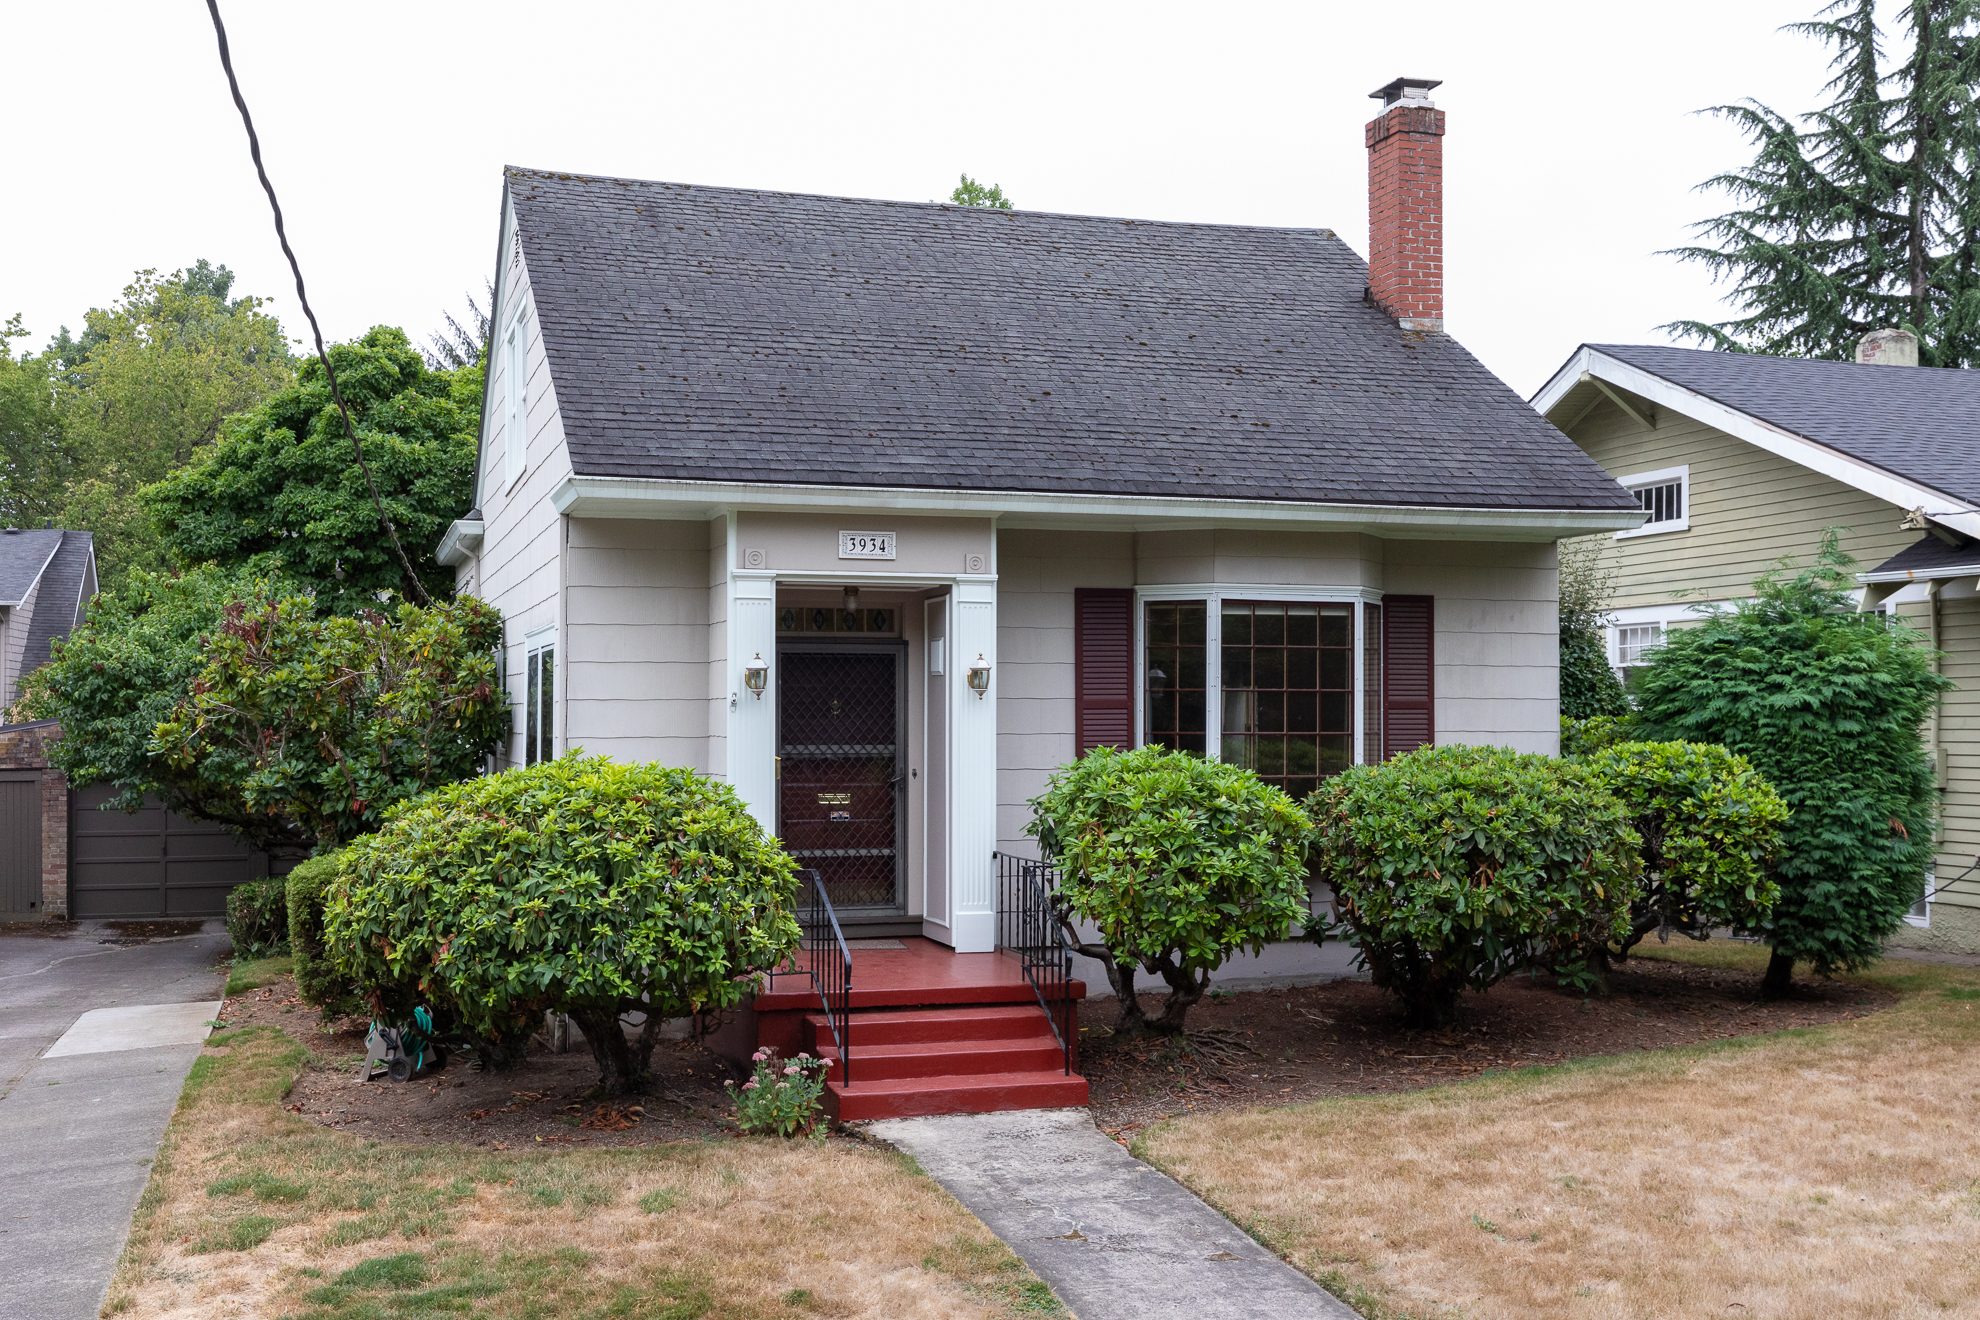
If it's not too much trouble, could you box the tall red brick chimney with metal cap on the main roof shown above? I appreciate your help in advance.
[1366,77,1443,330]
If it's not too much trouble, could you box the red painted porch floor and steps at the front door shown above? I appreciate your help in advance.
[756,938,1087,1120]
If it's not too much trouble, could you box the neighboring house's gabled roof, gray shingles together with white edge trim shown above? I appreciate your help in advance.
[1533,344,1980,534]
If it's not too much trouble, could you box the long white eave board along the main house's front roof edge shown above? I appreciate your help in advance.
[550,475,1645,540]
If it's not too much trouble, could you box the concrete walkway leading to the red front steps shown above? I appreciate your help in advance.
[867,1108,1354,1320]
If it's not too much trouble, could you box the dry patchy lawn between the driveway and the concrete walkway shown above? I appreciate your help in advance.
[105,1027,1063,1320]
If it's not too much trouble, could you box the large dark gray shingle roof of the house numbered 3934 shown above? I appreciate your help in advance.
[509,170,1634,509]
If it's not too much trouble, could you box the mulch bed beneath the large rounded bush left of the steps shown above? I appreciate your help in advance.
[220,976,737,1150]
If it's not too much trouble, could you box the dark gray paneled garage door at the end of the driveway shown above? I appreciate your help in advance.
[69,786,269,916]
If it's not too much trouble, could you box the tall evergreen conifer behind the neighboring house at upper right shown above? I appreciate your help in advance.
[1665,0,1980,366]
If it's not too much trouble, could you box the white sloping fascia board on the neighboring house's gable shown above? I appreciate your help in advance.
[1533,344,1980,538]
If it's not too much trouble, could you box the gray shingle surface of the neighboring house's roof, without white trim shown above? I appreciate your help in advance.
[1588,344,1980,501]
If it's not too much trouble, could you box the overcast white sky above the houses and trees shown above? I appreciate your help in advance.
[0,0,1826,394]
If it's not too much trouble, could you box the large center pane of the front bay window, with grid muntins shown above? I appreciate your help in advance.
[1218,600,1354,800]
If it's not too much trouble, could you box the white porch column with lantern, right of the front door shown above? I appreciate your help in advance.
[948,578,1002,954]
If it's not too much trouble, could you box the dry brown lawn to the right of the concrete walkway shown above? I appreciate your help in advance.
[1135,944,1980,1320]
